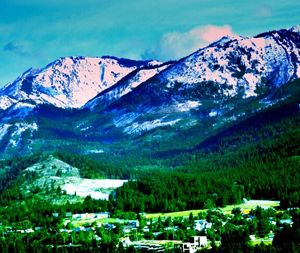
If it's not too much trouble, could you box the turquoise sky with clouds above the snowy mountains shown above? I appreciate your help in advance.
[0,0,300,87]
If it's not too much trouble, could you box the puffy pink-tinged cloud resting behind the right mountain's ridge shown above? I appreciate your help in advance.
[142,25,234,61]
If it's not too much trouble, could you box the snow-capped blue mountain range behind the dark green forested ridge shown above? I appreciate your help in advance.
[0,27,300,160]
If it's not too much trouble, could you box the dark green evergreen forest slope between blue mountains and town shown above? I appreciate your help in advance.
[52,100,300,212]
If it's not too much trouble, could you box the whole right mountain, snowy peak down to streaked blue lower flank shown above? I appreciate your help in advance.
[99,28,300,134]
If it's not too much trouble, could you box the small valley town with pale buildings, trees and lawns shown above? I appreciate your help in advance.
[0,201,299,253]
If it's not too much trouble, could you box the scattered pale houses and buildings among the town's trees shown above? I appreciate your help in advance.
[0,208,293,253]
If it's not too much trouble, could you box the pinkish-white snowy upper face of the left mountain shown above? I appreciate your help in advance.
[0,57,155,110]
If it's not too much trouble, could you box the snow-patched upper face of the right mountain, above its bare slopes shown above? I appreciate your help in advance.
[159,28,300,97]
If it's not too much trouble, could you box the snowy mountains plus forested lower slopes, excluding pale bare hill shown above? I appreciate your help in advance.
[0,27,300,212]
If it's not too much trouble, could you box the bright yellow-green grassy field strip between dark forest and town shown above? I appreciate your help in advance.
[146,200,280,219]
